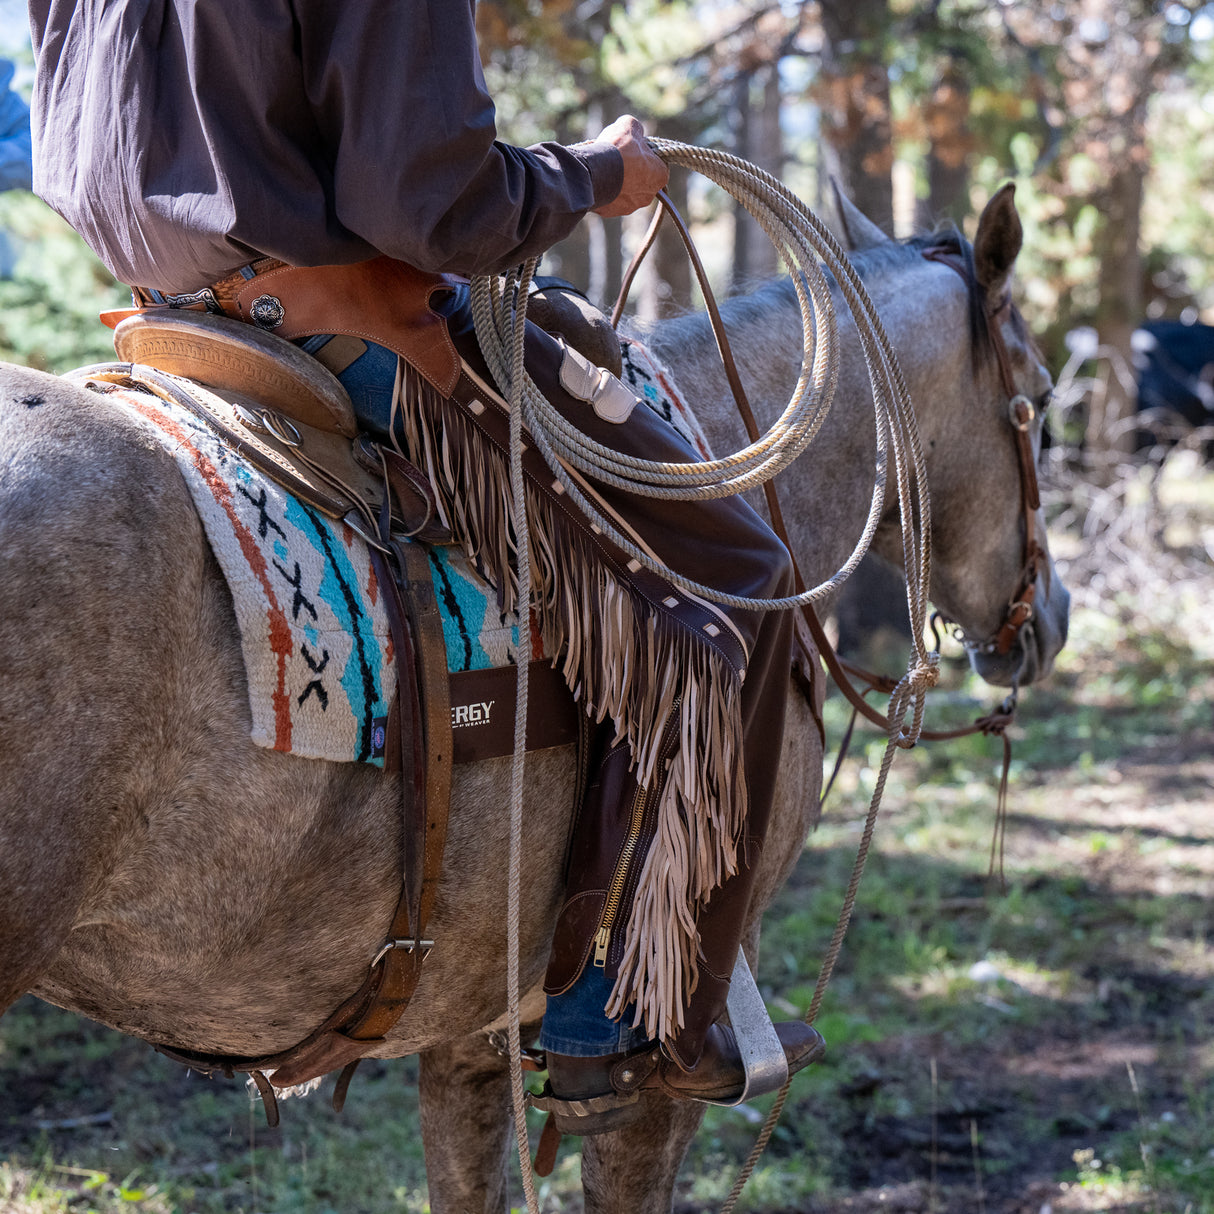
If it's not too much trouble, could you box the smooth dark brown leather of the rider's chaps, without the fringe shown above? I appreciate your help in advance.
[512,331,793,1070]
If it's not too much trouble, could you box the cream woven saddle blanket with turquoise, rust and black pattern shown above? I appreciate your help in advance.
[109,342,710,766]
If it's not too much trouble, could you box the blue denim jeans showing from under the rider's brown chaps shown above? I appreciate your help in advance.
[299,318,649,1057]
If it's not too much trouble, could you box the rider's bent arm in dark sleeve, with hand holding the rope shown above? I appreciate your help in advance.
[301,0,665,273]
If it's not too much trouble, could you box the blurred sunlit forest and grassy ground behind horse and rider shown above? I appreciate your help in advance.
[0,0,1214,1214]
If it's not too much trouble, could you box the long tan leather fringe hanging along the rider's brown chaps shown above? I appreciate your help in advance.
[393,361,747,1040]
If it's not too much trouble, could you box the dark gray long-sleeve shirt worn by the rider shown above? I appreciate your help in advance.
[29,0,623,291]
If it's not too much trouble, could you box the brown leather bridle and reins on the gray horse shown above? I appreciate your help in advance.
[611,191,1045,742]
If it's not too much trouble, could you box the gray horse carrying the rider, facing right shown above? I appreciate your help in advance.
[0,188,1067,1214]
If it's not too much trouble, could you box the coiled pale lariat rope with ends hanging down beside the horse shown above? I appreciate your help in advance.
[471,140,937,1214]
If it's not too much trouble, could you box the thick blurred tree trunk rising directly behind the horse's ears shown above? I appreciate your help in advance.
[813,0,894,232]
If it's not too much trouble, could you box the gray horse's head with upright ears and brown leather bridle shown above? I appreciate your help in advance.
[839,185,1070,686]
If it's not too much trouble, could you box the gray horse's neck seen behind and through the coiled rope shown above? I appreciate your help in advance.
[643,259,968,580]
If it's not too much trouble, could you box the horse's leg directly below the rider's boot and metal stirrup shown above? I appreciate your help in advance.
[582,1093,705,1214]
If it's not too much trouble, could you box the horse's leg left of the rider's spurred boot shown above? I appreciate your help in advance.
[418,1025,539,1214]
